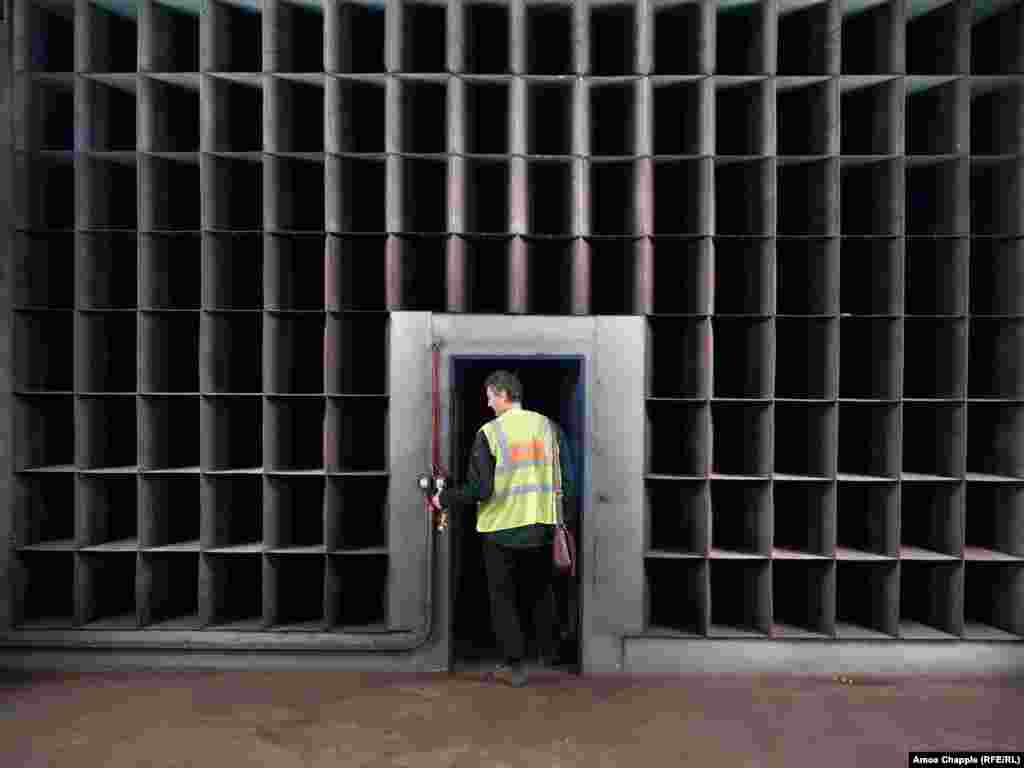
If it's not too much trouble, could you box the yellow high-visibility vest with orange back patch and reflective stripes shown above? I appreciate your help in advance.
[476,408,561,532]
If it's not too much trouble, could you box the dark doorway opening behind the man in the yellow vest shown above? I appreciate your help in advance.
[451,355,587,673]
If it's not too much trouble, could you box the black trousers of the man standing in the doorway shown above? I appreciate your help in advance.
[483,537,556,664]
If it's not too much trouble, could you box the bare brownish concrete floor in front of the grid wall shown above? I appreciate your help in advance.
[0,671,1024,768]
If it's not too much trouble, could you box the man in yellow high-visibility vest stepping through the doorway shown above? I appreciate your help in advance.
[433,371,571,687]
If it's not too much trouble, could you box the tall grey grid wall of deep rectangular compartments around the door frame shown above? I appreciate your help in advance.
[0,0,1024,671]
